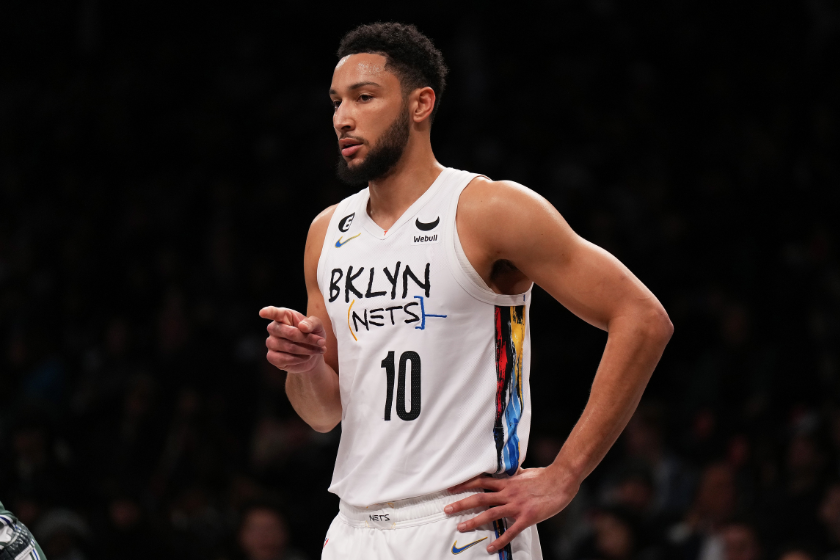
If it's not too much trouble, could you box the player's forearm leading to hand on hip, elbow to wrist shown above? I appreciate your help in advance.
[549,308,673,484]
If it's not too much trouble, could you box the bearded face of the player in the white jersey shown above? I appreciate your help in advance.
[330,53,411,185]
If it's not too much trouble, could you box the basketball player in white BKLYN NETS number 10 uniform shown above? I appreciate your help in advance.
[260,23,672,560]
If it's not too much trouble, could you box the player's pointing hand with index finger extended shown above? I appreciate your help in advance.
[260,307,327,373]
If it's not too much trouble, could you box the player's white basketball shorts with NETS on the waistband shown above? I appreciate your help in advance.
[321,491,542,560]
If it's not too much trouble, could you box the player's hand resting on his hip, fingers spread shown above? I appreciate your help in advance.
[443,467,580,554]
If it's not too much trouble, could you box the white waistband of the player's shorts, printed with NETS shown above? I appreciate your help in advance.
[338,490,481,529]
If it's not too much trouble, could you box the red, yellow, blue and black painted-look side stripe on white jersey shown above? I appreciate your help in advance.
[493,305,525,475]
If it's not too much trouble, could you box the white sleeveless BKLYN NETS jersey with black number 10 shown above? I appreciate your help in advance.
[318,168,531,507]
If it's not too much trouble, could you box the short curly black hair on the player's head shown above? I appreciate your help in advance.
[336,22,449,121]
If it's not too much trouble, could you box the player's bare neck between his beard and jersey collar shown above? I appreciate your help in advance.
[368,136,443,231]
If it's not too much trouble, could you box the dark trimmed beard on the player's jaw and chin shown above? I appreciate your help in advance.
[336,108,411,187]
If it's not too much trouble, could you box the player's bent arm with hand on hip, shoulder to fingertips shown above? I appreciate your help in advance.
[445,181,673,553]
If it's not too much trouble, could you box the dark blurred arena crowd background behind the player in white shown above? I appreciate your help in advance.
[0,0,840,560]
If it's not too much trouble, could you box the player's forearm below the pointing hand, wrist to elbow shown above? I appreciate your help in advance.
[286,359,341,432]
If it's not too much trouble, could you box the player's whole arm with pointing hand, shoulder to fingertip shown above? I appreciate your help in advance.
[260,206,341,432]
